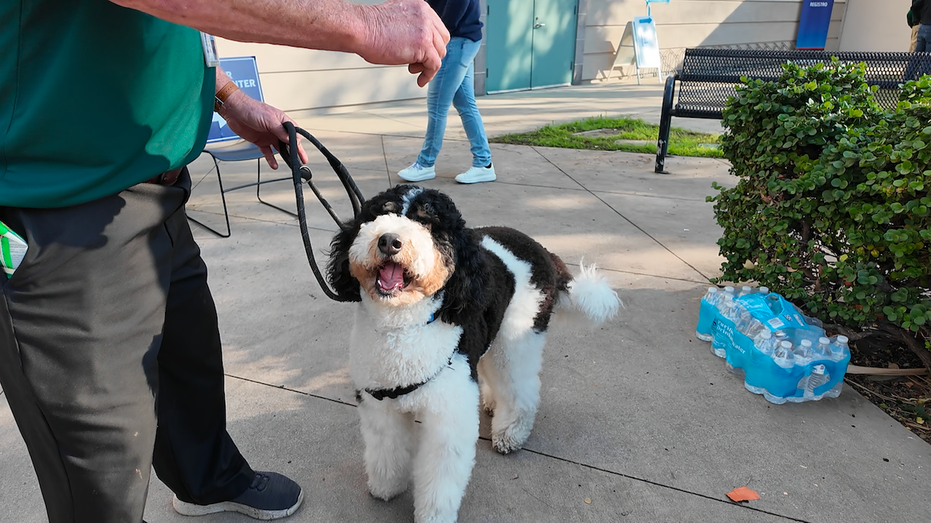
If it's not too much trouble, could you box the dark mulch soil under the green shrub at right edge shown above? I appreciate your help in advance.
[844,340,931,443]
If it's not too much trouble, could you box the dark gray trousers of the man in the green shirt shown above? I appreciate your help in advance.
[0,170,253,523]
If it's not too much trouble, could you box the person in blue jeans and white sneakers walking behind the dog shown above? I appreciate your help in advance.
[398,0,496,183]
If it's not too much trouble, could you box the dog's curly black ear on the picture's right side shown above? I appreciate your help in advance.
[437,228,485,324]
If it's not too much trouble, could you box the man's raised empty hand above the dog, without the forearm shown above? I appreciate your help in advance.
[356,0,449,87]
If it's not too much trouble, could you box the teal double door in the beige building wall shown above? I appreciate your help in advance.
[485,0,578,92]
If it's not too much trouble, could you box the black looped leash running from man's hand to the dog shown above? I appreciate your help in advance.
[278,122,365,301]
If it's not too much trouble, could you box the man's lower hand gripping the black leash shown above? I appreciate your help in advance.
[220,90,307,169]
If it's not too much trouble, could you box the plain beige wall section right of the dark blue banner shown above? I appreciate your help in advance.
[839,0,912,51]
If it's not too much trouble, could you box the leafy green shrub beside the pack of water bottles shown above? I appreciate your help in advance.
[709,62,931,368]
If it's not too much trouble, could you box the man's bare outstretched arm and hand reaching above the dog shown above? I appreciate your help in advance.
[111,0,449,87]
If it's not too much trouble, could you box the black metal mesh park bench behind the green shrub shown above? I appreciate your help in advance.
[654,48,931,173]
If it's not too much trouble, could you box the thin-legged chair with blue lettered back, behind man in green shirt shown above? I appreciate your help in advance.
[188,56,297,238]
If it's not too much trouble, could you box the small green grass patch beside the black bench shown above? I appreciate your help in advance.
[489,116,723,158]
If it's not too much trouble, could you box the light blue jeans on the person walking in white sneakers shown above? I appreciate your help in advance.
[417,36,491,167]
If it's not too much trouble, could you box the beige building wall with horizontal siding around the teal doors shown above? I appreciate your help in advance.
[217,0,868,111]
